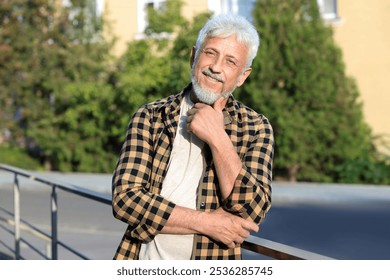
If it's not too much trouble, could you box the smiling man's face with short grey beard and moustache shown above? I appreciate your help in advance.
[191,35,251,104]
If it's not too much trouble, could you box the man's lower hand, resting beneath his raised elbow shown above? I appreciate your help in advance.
[199,208,259,248]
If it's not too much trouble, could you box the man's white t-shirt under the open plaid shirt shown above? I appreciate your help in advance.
[139,94,204,260]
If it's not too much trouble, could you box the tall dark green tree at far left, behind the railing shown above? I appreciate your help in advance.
[0,0,115,171]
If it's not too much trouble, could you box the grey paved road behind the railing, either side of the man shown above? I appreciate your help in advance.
[0,173,390,259]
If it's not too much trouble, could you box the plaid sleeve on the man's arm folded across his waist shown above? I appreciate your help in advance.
[112,107,175,242]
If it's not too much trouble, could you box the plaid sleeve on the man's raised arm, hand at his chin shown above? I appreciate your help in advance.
[224,112,274,224]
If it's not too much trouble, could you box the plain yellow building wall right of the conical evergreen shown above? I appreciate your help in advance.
[334,0,390,154]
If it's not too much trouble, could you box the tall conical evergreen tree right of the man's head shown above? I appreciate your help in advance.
[240,0,372,181]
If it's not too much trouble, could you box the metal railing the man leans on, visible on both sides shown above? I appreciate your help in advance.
[0,164,331,260]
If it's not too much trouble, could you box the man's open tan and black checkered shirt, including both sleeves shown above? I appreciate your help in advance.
[112,85,274,260]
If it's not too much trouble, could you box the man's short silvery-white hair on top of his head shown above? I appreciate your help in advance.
[195,14,260,67]
